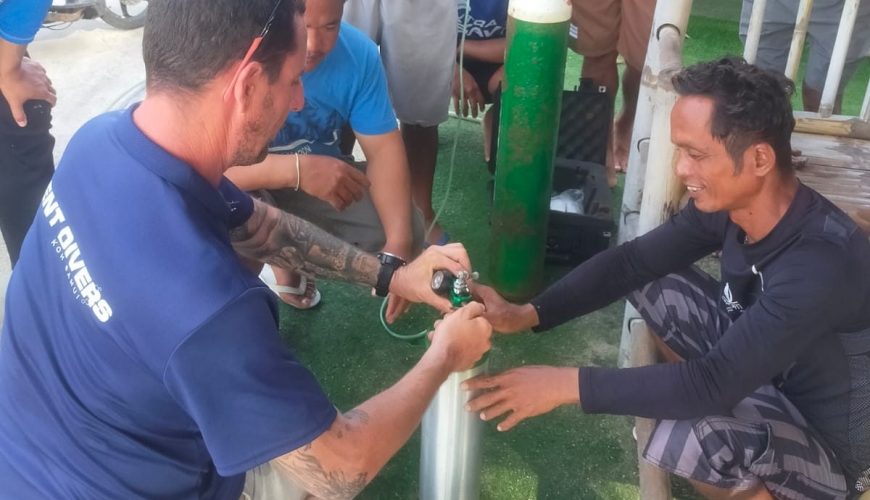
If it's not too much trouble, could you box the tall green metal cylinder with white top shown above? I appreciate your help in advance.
[490,0,571,299]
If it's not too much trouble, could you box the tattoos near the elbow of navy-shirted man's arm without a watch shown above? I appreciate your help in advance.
[274,410,370,499]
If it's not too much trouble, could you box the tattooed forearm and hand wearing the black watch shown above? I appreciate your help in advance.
[230,199,471,312]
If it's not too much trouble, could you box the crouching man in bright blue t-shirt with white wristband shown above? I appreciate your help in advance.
[227,0,423,318]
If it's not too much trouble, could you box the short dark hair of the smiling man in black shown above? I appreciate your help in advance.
[672,56,794,172]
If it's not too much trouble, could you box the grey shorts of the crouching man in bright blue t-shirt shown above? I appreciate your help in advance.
[257,163,425,255]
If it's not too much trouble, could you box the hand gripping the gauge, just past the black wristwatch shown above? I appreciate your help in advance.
[390,243,471,313]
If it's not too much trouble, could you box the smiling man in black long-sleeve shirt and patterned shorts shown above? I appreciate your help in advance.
[469,59,870,499]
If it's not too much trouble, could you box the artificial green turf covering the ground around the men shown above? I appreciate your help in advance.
[281,11,870,500]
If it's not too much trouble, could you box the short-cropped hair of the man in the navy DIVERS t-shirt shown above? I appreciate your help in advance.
[142,0,305,91]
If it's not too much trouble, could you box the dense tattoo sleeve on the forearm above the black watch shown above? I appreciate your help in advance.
[230,199,380,286]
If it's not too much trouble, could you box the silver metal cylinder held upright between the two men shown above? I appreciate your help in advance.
[420,359,488,500]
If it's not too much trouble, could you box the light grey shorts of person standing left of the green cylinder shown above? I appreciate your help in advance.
[344,0,458,126]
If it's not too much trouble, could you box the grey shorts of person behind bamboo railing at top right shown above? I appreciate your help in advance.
[740,0,870,92]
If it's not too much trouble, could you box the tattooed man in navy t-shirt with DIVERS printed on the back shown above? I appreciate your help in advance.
[0,0,490,499]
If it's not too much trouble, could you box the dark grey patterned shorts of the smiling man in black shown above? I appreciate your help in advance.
[629,268,849,499]
